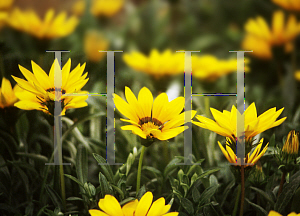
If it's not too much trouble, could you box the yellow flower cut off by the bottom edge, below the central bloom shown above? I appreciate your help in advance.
[89,192,179,216]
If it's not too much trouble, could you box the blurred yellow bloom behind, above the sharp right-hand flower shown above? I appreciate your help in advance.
[192,55,249,81]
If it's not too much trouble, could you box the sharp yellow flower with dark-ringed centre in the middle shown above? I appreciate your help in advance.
[114,87,196,140]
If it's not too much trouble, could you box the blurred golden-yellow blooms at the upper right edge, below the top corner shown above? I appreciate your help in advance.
[242,11,300,59]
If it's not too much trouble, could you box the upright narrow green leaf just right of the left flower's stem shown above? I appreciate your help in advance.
[76,145,88,184]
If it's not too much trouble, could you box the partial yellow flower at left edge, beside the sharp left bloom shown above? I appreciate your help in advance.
[0,77,22,109]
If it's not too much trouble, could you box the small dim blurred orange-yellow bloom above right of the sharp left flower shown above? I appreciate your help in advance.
[84,31,109,62]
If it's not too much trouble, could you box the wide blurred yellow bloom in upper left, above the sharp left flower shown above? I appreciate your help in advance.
[7,8,78,39]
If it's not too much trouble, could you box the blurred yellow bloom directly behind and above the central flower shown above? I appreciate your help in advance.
[123,49,184,78]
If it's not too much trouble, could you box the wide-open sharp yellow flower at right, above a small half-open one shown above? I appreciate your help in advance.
[192,103,286,141]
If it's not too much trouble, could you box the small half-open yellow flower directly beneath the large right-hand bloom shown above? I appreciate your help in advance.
[218,138,269,166]
